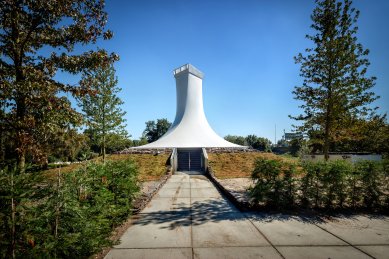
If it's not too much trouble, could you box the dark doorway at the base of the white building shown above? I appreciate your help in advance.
[177,148,203,171]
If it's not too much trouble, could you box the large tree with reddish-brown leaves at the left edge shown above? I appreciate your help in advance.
[0,0,118,172]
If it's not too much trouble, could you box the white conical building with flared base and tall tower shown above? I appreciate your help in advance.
[138,64,242,148]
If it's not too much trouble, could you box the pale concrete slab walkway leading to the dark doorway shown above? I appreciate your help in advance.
[105,173,389,259]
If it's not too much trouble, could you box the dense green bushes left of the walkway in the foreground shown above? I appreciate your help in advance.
[0,160,139,258]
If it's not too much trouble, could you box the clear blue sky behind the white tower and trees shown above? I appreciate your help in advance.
[67,0,389,141]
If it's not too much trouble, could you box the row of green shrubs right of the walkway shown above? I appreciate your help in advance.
[249,158,389,211]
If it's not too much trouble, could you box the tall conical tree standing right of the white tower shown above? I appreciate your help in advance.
[291,0,378,159]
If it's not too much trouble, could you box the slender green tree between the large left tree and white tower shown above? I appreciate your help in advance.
[79,66,128,162]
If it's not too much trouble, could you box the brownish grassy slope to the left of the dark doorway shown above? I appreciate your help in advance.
[47,154,170,181]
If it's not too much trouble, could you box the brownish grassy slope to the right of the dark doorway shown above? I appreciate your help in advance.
[208,152,295,179]
